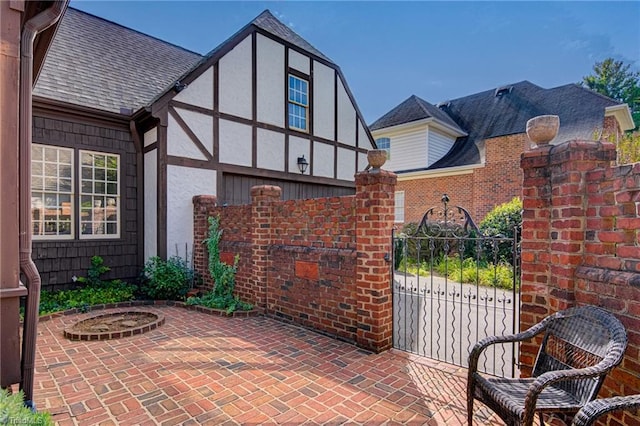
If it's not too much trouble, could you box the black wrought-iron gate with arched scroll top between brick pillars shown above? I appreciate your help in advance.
[392,194,520,377]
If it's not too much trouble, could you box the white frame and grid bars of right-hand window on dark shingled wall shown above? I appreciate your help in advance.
[78,150,122,240]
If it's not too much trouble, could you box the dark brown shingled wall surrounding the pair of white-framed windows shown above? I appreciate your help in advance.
[33,113,142,290]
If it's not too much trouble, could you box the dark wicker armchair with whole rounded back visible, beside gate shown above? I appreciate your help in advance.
[467,306,627,426]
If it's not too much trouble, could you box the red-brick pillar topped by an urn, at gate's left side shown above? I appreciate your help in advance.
[356,170,397,352]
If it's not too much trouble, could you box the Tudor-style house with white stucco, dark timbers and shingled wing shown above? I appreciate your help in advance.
[32,8,375,288]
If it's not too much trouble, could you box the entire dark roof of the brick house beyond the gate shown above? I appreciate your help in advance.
[370,81,620,169]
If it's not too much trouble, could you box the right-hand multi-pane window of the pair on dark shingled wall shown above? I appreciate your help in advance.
[80,151,120,238]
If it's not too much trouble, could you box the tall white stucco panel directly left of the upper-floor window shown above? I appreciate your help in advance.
[256,34,285,127]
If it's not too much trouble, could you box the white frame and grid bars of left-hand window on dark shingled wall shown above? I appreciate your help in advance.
[31,144,75,241]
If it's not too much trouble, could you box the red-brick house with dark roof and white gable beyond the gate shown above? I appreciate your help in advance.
[370,81,633,223]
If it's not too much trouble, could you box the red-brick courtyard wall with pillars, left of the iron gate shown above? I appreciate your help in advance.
[194,171,396,351]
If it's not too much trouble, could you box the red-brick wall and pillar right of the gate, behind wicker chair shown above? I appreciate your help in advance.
[520,141,640,424]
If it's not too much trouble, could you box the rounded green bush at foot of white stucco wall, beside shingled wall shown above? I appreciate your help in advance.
[141,256,194,300]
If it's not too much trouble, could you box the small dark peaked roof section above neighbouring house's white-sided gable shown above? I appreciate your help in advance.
[369,95,464,133]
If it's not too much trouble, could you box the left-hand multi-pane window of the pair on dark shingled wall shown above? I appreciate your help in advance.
[31,144,73,239]
